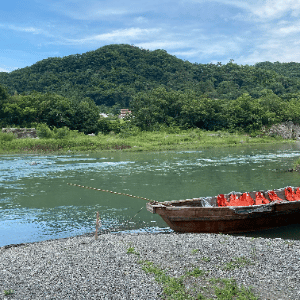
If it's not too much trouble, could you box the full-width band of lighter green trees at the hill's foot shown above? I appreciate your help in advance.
[0,82,300,133]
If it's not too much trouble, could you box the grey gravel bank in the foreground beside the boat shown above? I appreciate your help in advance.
[0,233,300,300]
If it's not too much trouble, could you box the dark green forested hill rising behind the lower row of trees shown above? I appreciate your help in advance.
[0,45,300,107]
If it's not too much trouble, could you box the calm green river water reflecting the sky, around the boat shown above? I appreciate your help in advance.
[0,144,300,246]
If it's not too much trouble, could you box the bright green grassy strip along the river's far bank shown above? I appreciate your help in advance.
[0,129,294,154]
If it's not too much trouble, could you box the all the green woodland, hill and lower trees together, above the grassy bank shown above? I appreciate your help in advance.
[0,45,300,133]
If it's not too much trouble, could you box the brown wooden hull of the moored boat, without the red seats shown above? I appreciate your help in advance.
[147,196,300,233]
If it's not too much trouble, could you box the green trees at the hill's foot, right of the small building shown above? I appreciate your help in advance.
[131,87,300,132]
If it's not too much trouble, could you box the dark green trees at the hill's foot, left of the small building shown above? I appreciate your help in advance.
[2,92,99,133]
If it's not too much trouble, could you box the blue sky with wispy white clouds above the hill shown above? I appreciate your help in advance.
[0,0,300,72]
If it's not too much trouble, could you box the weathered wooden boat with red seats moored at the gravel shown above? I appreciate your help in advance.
[147,187,300,233]
